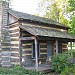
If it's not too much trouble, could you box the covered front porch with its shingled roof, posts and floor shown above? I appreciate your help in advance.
[20,26,75,71]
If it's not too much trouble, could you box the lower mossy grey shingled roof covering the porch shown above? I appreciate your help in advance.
[20,25,75,40]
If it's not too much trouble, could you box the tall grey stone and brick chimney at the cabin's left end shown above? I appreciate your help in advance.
[0,1,11,67]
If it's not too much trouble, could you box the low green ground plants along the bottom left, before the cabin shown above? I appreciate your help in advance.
[0,66,44,75]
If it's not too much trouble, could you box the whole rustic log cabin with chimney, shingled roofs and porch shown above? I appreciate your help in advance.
[0,1,75,70]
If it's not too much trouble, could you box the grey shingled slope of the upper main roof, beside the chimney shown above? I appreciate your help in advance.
[8,9,69,28]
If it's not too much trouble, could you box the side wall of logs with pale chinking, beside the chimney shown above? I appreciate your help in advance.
[9,22,20,64]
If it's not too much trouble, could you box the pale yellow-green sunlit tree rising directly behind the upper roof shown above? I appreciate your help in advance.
[38,0,70,25]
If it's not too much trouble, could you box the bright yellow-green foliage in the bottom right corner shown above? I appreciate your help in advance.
[60,64,75,75]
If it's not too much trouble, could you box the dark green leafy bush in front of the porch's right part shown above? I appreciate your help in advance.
[52,53,70,73]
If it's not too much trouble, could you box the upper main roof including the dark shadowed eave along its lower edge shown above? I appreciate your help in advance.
[8,9,69,29]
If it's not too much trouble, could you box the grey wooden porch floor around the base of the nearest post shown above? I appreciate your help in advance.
[25,64,51,71]
